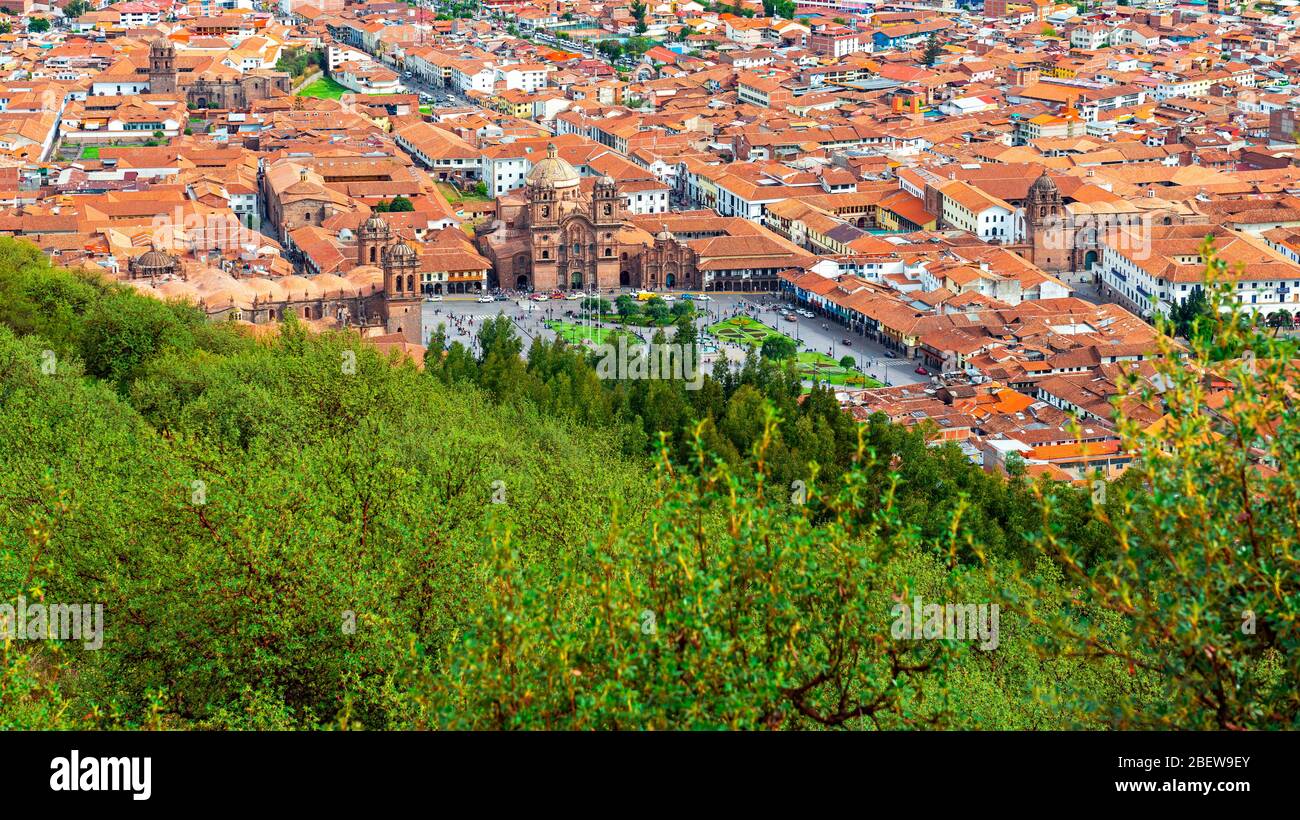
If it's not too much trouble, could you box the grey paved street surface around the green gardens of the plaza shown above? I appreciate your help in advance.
[424,294,927,385]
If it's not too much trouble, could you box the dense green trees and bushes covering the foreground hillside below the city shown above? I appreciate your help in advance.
[0,239,1300,729]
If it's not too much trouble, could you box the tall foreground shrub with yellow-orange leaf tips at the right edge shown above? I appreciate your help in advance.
[1003,240,1300,729]
